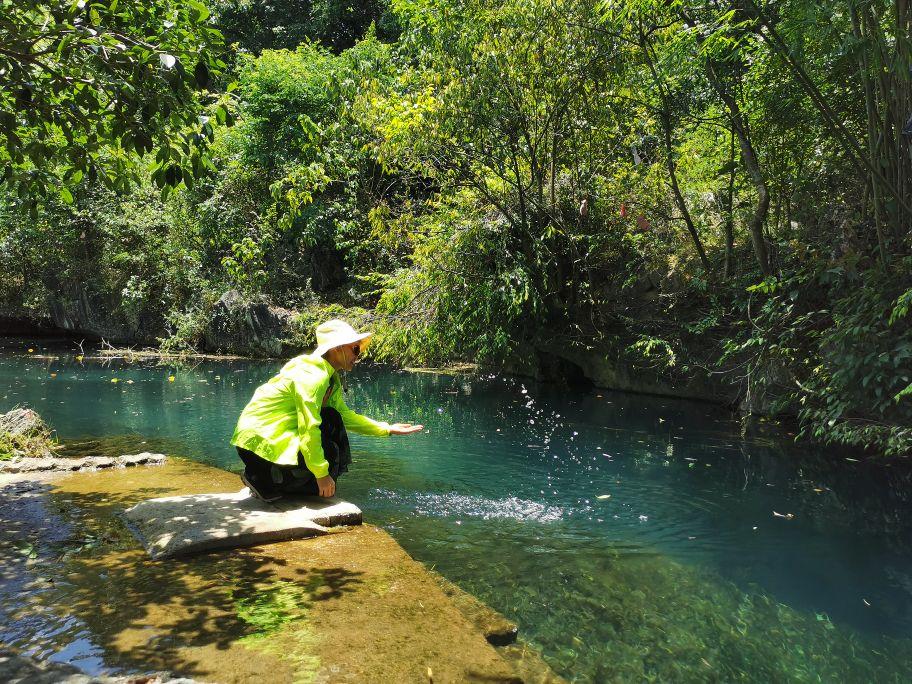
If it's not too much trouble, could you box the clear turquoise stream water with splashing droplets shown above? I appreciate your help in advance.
[0,347,912,681]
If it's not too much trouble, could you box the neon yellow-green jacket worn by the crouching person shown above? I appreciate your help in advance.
[231,354,390,477]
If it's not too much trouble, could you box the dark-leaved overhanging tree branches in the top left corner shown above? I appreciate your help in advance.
[0,0,228,202]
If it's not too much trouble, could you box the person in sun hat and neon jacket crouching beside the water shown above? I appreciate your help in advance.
[231,320,424,501]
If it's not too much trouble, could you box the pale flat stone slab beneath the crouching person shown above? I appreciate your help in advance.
[124,487,361,559]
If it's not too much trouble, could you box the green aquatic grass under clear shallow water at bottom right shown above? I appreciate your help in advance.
[452,549,912,682]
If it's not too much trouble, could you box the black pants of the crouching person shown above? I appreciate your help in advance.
[237,406,351,496]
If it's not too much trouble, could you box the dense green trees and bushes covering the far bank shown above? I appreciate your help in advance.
[0,0,912,453]
